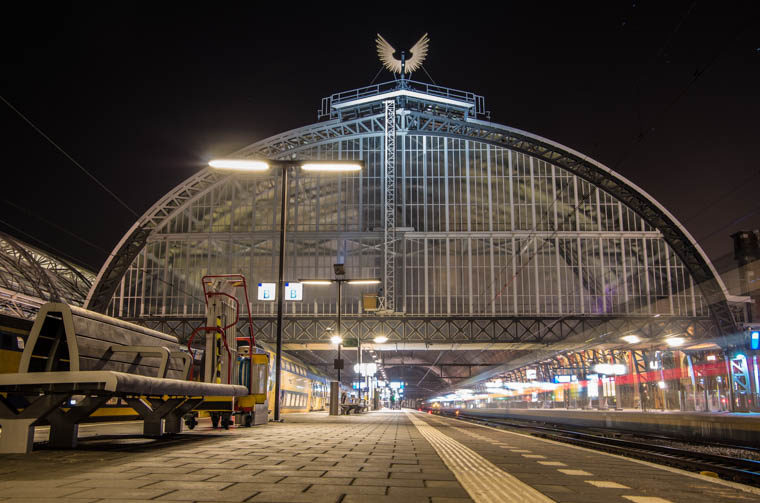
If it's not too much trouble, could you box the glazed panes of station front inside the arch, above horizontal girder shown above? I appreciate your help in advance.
[109,137,708,318]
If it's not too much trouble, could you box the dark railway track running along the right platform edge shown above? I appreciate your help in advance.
[436,413,760,487]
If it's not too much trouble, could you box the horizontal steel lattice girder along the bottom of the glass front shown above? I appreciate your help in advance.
[129,316,718,349]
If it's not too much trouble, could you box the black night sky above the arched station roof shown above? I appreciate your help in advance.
[0,1,760,269]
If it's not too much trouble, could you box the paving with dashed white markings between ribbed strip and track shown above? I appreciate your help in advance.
[416,413,760,503]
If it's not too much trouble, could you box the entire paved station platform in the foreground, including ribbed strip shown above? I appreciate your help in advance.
[0,411,760,503]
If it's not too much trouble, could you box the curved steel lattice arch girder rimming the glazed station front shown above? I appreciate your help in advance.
[87,111,739,335]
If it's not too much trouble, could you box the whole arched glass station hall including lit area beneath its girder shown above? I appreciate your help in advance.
[80,79,760,411]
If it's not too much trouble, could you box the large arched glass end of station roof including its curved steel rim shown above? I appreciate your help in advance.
[88,80,736,337]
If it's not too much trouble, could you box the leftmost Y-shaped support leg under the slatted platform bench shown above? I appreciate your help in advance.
[0,393,71,454]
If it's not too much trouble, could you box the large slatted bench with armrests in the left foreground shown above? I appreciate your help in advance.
[0,303,248,453]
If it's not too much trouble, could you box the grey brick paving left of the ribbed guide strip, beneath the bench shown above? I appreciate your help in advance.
[0,412,472,503]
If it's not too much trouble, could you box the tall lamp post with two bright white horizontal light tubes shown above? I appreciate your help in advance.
[208,159,364,421]
